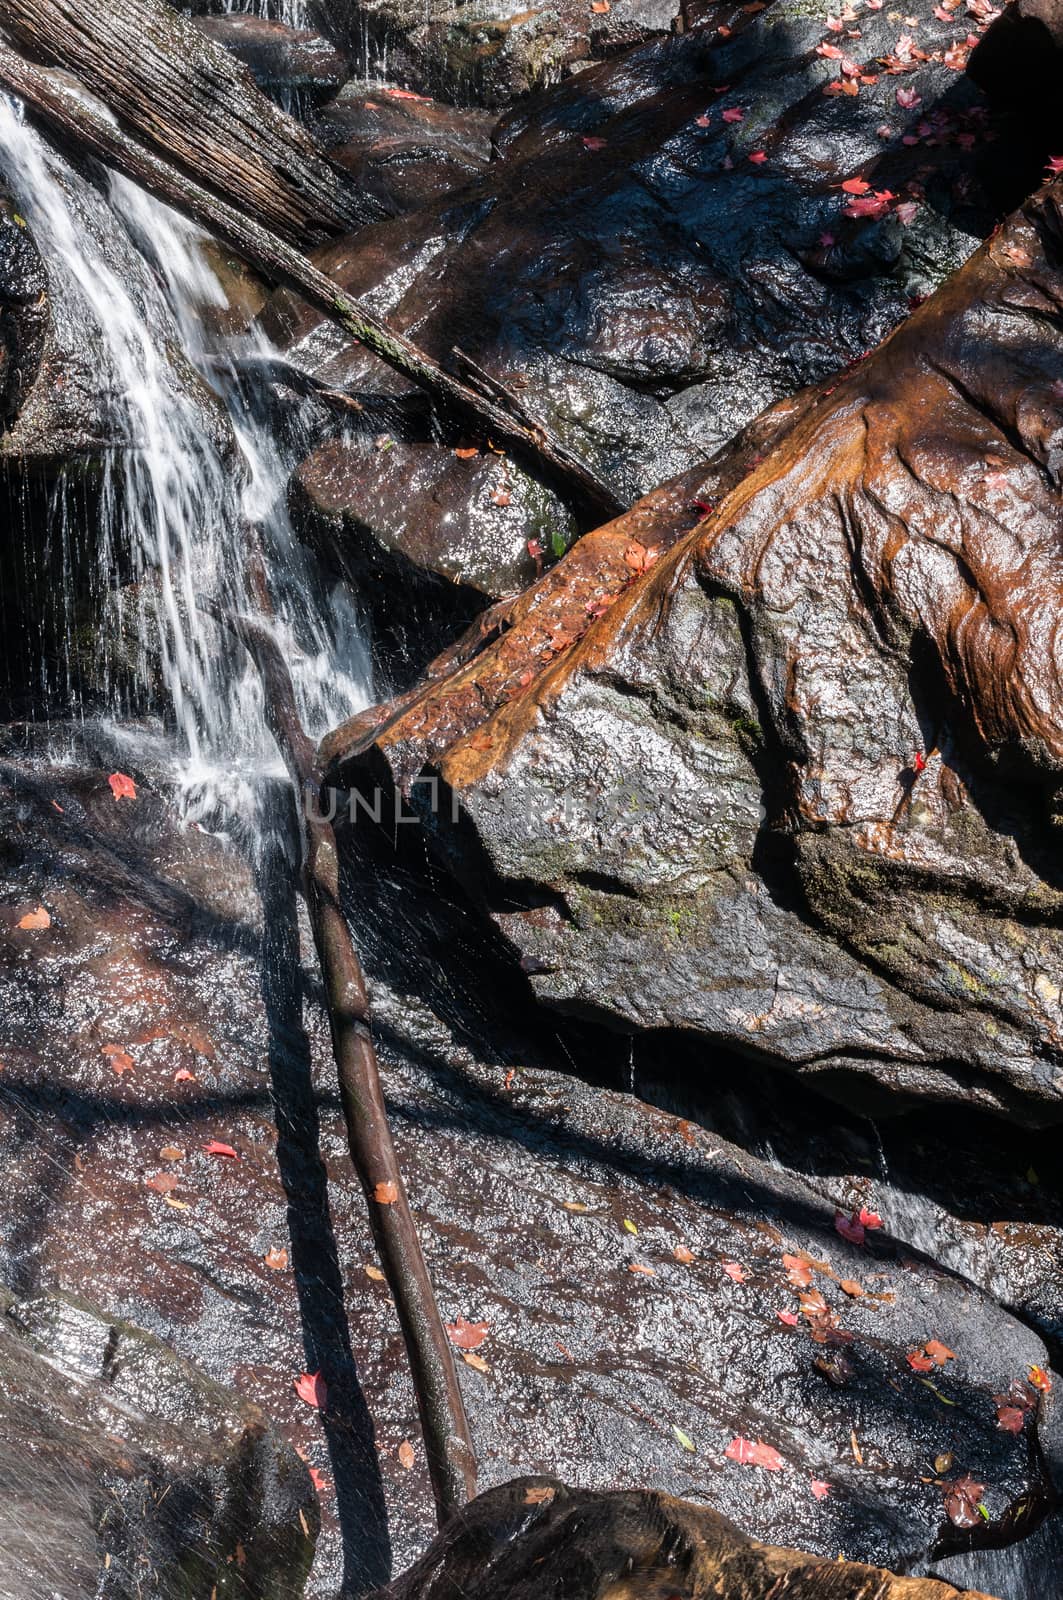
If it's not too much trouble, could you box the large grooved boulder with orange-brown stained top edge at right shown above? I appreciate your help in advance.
[323,162,1063,1122]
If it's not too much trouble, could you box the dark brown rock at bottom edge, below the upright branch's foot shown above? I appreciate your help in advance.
[376,1478,988,1600]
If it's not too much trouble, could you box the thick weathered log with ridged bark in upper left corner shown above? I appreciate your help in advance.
[0,0,384,246]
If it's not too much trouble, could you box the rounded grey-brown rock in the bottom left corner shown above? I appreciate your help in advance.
[0,1293,317,1600]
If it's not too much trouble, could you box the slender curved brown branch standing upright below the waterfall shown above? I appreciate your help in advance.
[203,601,477,1526]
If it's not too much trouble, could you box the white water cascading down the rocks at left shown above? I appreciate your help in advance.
[0,101,370,805]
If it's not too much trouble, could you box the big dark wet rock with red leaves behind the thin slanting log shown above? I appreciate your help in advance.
[266,0,1044,598]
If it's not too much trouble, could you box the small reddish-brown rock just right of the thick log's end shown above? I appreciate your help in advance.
[314,83,495,213]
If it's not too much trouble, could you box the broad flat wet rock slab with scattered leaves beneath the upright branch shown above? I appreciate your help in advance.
[0,763,1055,1595]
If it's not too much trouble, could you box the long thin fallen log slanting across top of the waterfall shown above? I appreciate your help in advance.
[0,45,624,526]
